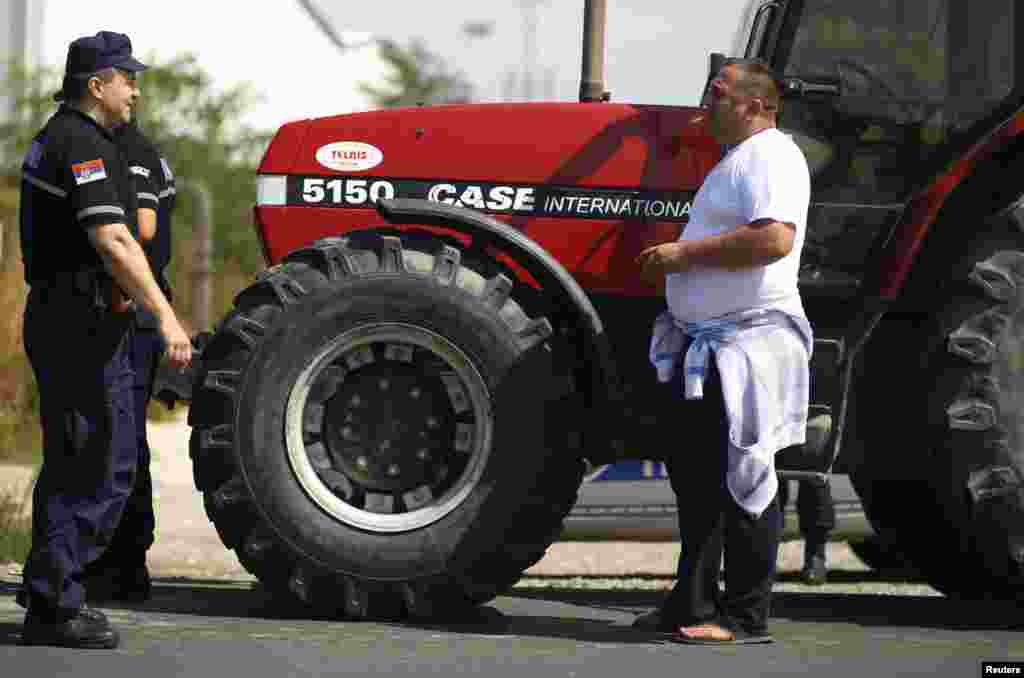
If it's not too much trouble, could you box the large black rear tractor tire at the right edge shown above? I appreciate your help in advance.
[851,223,1024,600]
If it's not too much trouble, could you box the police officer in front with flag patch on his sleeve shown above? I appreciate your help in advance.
[18,31,191,647]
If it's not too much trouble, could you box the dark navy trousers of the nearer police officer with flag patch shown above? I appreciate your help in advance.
[18,289,138,617]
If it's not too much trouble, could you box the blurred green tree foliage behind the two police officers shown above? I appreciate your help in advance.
[0,54,270,330]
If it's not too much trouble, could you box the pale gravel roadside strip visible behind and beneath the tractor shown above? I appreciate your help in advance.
[0,416,940,596]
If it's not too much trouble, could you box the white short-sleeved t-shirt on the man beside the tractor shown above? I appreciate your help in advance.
[666,128,811,323]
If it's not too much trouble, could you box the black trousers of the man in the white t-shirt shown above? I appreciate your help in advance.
[662,357,782,633]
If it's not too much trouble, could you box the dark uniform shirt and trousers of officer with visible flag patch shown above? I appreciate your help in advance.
[19,107,138,623]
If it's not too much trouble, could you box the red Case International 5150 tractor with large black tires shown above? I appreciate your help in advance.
[167,0,1024,618]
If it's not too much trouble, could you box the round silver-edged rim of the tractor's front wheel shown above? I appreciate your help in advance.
[285,323,493,533]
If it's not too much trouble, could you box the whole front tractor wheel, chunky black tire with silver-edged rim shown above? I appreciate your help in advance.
[189,237,584,619]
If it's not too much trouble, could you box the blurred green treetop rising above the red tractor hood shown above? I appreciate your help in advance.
[358,40,472,109]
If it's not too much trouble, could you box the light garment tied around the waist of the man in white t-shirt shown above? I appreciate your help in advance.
[649,309,814,516]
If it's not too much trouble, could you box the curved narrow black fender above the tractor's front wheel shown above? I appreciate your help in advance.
[377,199,622,448]
